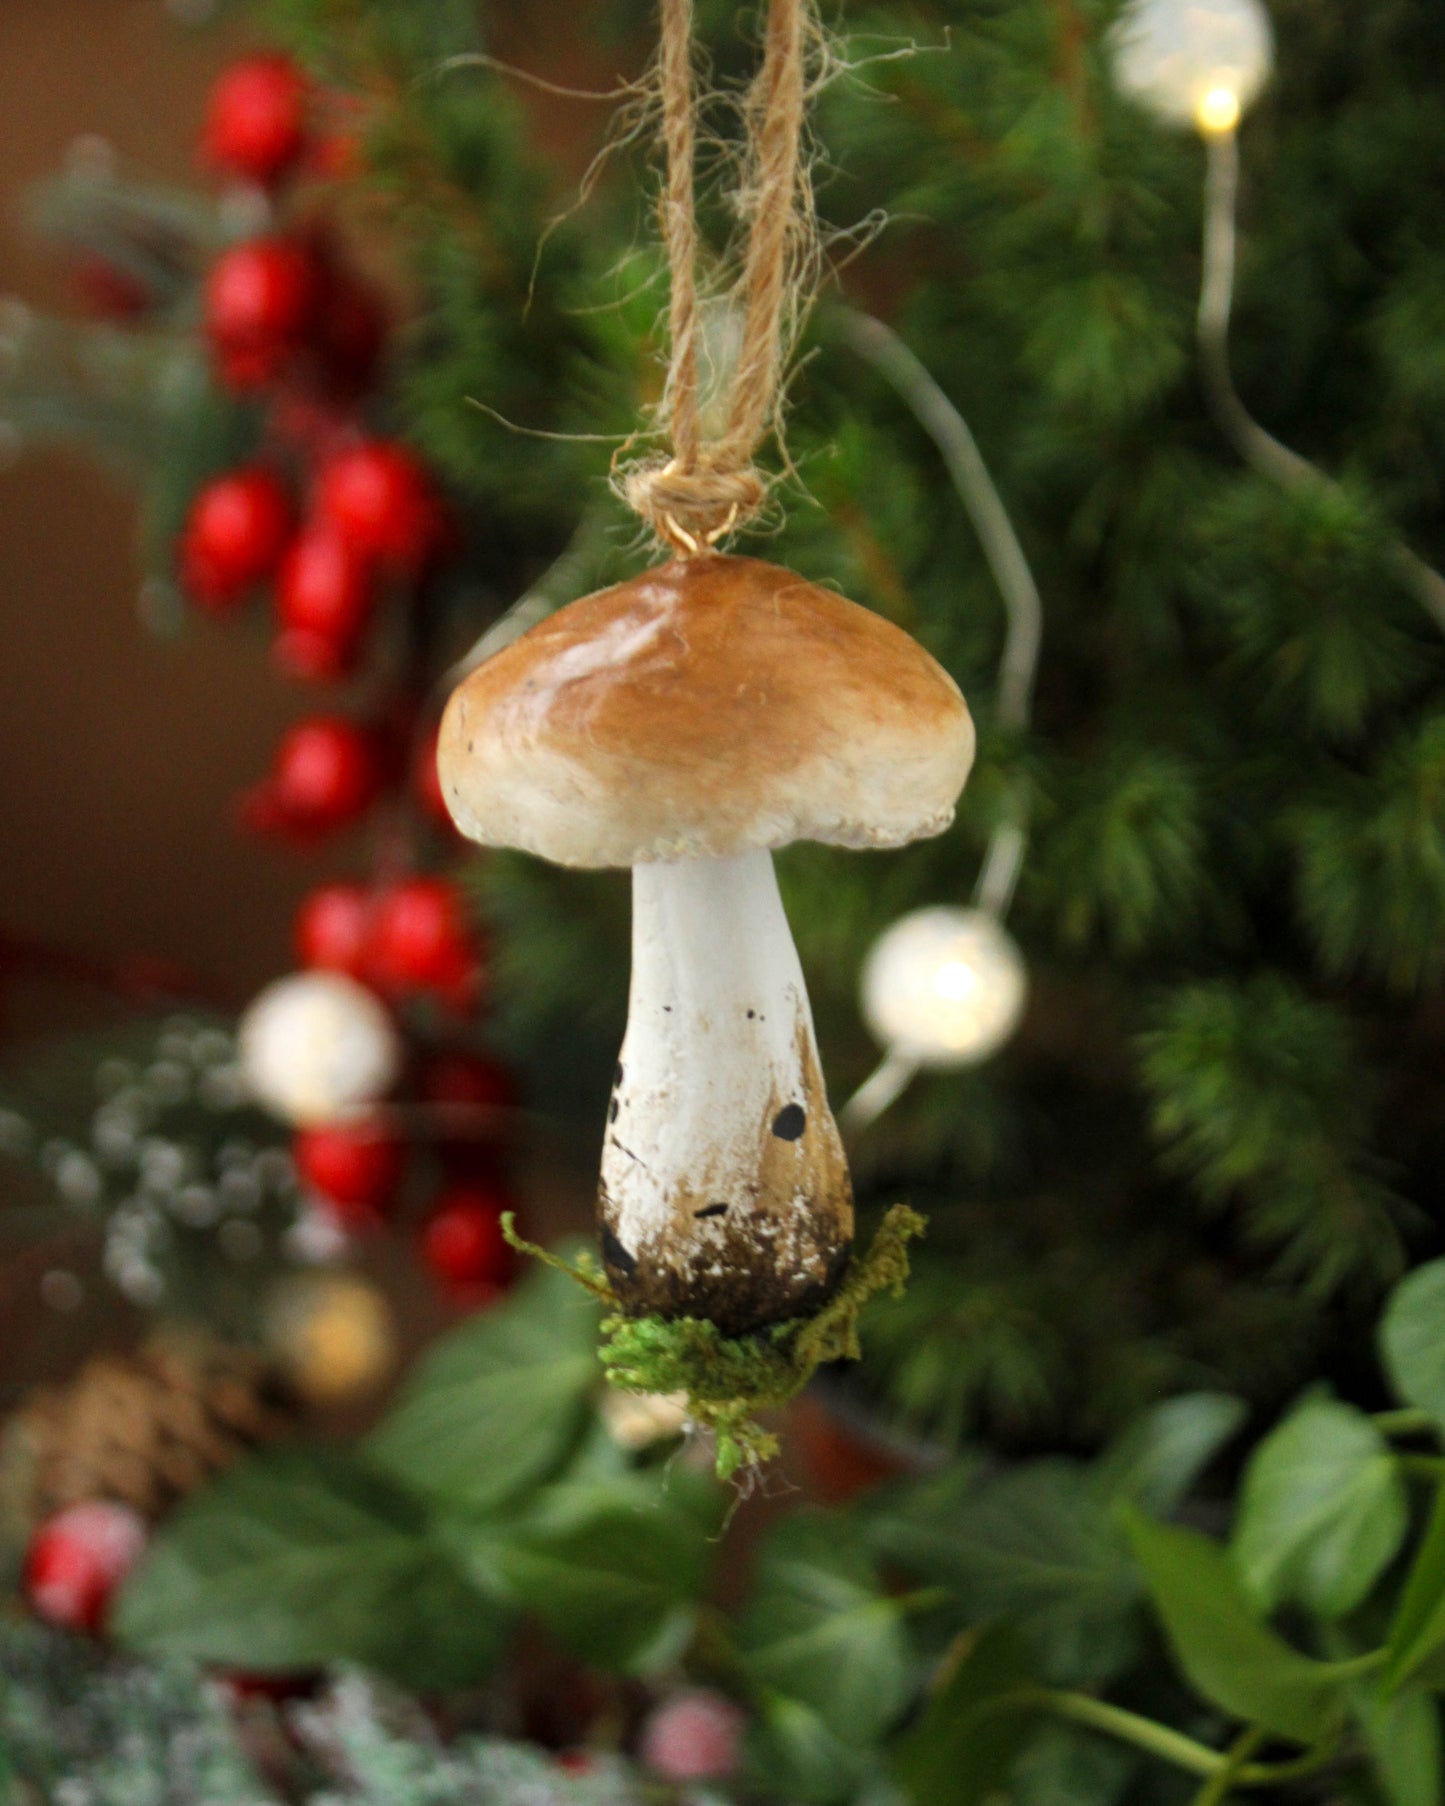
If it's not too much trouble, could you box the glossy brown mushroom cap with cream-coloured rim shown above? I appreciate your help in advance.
[437,553,974,867]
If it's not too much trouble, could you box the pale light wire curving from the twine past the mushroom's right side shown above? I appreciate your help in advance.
[838,309,1044,1140]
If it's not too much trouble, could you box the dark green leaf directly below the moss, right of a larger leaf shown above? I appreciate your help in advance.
[495,1486,708,1671]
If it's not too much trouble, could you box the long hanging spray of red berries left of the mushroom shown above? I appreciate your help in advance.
[177,54,517,1302]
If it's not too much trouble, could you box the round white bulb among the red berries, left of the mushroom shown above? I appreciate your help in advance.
[237,972,401,1125]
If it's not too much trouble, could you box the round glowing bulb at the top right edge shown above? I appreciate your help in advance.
[1113,0,1273,134]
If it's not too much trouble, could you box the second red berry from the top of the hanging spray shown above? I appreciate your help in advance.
[206,238,323,388]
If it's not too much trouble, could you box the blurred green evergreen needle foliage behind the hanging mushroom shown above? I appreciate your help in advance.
[7,0,1445,1439]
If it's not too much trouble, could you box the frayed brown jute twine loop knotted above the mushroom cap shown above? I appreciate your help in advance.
[616,0,822,554]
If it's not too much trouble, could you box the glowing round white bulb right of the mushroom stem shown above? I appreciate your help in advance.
[863,908,1028,1067]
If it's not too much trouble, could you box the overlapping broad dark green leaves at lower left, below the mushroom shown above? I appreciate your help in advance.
[117,1273,712,1689]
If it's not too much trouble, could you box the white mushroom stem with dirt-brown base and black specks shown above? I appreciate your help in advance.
[601,852,853,1333]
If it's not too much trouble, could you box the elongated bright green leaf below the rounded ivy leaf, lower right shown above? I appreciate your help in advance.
[1125,1508,1346,1743]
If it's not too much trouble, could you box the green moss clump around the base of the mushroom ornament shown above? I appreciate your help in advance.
[502,1205,927,1481]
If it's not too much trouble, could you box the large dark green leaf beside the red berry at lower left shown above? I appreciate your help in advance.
[114,1450,504,1689]
